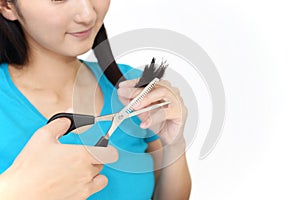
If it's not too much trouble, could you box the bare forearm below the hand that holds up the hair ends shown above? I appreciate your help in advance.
[147,140,191,200]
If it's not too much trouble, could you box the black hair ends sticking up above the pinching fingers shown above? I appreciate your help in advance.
[135,58,168,88]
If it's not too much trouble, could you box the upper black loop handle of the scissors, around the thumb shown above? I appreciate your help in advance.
[47,113,95,135]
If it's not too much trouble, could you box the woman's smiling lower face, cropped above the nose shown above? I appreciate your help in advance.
[11,0,110,56]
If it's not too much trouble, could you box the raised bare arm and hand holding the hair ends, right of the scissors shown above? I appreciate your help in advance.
[118,79,191,200]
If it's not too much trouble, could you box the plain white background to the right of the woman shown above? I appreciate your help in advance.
[105,0,300,200]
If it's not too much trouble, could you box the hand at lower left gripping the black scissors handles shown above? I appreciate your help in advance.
[0,118,118,200]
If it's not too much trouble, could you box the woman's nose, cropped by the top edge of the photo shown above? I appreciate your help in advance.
[74,0,96,25]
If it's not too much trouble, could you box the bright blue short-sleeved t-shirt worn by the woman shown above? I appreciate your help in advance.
[0,62,158,200]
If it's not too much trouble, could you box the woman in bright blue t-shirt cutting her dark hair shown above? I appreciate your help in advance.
[0,0,191,199]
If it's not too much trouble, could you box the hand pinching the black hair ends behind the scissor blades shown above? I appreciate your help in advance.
[118,79,187,146]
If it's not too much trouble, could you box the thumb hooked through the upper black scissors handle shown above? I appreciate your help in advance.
[37,118,71,141]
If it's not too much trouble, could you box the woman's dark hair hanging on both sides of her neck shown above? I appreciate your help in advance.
[0,2,124,86]
